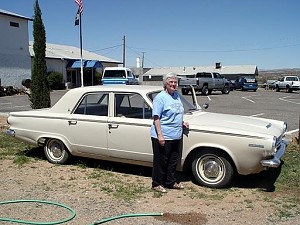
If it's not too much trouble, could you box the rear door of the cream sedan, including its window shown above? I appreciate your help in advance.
[68,92,109,155]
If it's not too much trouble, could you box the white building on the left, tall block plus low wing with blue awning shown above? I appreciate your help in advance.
[0,9,122,88]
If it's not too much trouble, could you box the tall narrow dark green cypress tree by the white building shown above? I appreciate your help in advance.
[29,0,51,109]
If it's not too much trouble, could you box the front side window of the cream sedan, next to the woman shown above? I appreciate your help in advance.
[114,93,152,119]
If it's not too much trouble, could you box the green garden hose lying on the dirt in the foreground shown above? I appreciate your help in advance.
[0,200,163,225]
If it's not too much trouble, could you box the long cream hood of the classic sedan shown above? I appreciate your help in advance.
[184,111,284,138]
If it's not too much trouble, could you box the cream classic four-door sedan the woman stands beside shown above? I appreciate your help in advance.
[6,85,287,188]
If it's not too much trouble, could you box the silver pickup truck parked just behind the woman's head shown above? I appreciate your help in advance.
[178,72,230,95]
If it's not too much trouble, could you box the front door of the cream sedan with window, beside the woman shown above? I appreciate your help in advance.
[108,93,153,162]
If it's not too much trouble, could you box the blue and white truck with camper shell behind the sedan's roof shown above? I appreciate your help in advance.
[101,67,139,85]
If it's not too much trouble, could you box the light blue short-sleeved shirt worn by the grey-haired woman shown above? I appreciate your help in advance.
[151,91,184,140]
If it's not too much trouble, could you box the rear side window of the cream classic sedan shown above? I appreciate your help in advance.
[74,93,108,116]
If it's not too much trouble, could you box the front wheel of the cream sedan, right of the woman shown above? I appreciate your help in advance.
[192,151,234,188]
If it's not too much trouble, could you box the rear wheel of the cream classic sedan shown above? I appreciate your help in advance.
[44,139,70,164]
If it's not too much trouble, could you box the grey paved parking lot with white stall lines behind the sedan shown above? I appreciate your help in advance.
[0,89,300,135]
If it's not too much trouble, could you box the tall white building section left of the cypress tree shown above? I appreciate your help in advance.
[0,9,32,87]
